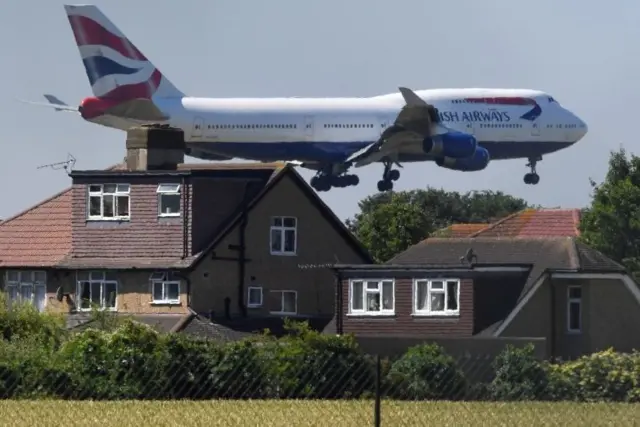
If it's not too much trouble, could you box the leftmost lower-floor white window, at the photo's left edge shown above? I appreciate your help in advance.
[5,270,47,311]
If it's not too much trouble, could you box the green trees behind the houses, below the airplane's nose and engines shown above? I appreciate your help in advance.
[346,188,528,262]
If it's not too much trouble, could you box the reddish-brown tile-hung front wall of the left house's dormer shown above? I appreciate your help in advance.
[72,176,184,258]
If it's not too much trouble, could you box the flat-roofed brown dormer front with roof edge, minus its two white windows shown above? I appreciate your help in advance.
[333,264,531,338]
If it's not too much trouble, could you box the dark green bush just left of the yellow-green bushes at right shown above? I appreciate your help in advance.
[488,344,549,400]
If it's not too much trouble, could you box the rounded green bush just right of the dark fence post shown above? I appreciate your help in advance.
[386,344,465,400]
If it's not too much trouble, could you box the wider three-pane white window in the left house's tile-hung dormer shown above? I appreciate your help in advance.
[88,184,130,220]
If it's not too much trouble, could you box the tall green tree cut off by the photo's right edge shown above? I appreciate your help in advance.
[580,148,640,278]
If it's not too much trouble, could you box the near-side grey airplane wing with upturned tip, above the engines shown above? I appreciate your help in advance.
[346,87,444,167]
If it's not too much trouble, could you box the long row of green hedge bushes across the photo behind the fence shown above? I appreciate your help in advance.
[0,300,640,402]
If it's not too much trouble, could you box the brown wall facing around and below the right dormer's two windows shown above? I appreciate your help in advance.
[342,277,473,337]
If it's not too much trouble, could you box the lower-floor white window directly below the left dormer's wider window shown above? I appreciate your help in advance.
[76,271,118,311]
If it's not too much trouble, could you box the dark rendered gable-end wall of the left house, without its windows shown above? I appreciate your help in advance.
[191,177,364,317]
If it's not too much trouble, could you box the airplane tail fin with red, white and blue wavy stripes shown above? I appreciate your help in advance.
[64,5,184,101]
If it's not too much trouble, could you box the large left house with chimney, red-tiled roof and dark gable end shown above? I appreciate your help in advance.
[0,127,371,335]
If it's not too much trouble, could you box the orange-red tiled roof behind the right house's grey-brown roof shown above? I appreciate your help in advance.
[465,209,580,237]
